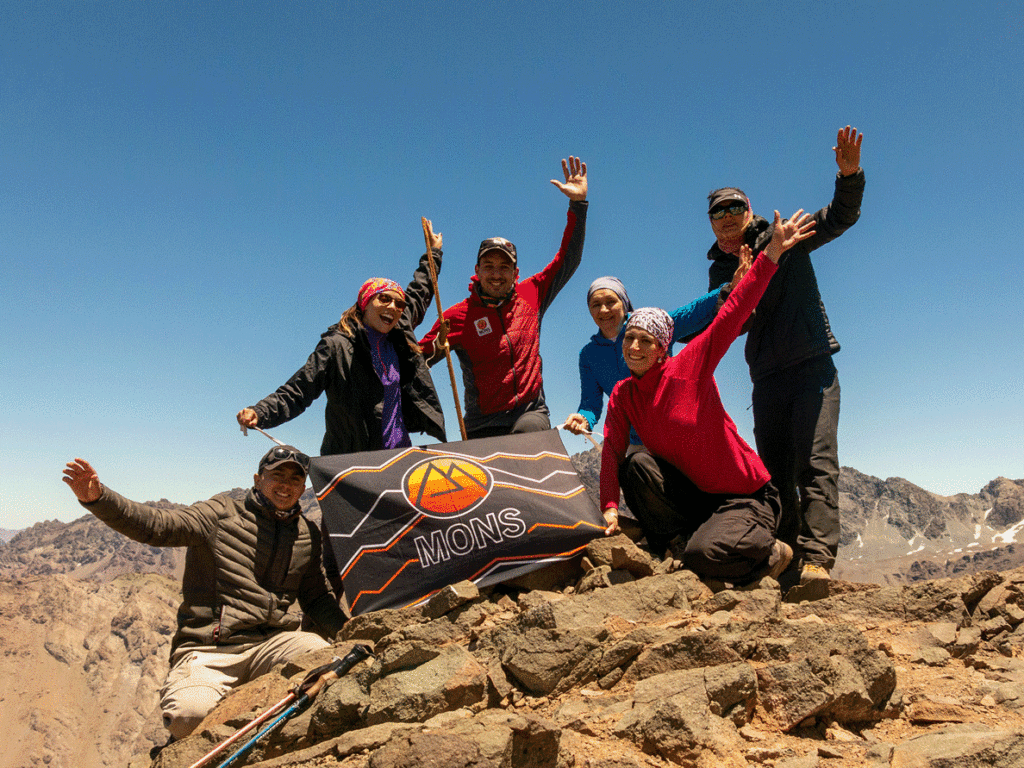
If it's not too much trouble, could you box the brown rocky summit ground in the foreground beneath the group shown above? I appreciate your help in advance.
[130,537,1024,768]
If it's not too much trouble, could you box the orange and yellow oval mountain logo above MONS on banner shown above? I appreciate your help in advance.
[401,456,494,517]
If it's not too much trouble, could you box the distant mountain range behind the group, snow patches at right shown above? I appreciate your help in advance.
[0,462,1024,584]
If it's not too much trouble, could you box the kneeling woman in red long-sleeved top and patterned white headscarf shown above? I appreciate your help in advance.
[601,211,814,583]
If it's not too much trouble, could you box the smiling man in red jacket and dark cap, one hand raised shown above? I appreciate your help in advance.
[420,157,587,438]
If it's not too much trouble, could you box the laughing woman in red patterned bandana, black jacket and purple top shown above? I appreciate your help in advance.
[237,222,445,456]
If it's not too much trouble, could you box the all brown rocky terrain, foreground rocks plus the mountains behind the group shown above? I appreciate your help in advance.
[0,468,1024,768]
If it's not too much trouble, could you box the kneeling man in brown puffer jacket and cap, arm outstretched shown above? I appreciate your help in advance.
[63,445,346,738]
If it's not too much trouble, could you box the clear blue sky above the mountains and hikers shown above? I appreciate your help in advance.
[0,0,1024,528]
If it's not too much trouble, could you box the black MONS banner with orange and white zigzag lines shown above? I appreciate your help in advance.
[309,429,604,615]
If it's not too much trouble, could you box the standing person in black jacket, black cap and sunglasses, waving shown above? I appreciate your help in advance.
[708,126,864,582]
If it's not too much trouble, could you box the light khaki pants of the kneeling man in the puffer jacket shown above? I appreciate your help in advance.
[160,632,330,738]
